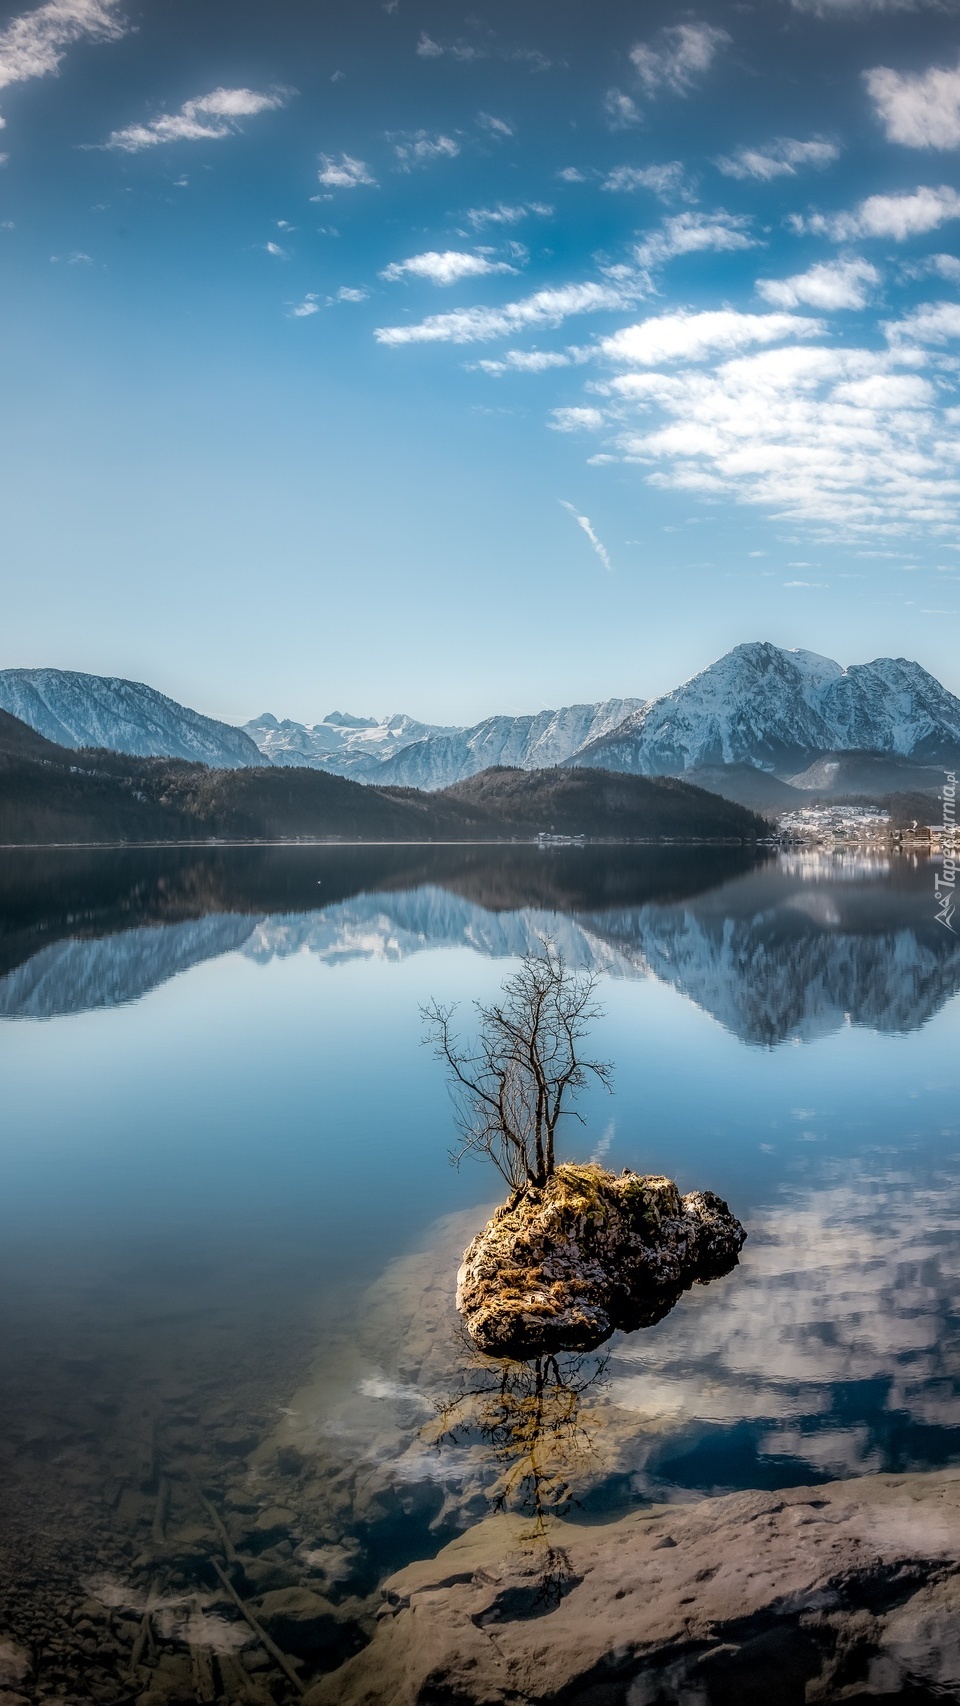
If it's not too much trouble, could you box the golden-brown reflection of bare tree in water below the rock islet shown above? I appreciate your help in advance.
[430,1353,607,1537]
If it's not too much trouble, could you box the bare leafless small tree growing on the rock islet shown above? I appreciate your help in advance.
[423,942,612,1191]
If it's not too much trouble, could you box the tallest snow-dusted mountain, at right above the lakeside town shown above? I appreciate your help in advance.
[573,641,960,776]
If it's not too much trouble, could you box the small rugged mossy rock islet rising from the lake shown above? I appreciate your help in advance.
[457,1165,747,1358]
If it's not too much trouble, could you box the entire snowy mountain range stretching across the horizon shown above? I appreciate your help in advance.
[0,641,960,791]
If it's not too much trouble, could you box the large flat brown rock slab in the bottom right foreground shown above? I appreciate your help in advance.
[305,1469,960,1706]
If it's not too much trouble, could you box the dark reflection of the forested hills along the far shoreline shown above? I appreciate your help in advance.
[0,844,757,996]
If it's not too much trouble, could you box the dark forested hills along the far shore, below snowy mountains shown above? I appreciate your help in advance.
[0,711,766,846]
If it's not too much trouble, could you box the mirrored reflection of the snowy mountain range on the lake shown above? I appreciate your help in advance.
[0,848,960,1046]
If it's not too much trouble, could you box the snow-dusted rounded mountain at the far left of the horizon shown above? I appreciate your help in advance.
[0,669,269,769]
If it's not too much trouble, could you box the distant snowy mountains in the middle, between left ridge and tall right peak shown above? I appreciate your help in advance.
[244,699,643,790]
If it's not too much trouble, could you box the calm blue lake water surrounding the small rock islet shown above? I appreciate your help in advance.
[0,848,960,1699]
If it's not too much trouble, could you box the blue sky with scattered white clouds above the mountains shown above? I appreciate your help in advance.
[0,0,960,722]
